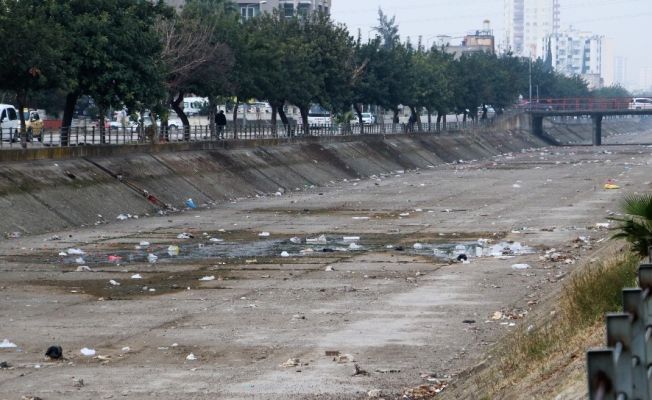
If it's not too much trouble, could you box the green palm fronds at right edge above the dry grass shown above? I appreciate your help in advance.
[609,193,652,257]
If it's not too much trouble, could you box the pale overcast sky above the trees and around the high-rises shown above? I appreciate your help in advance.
[332,0,652,87]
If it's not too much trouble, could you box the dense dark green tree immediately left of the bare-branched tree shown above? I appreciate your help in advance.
[55,0,171,145]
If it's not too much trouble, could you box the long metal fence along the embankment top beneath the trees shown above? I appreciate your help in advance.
[0,118,495,149]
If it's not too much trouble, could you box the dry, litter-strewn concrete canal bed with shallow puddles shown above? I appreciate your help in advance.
[0,146,652,400]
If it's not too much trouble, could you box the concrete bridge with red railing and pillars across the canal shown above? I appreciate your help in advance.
[525,97,652,146]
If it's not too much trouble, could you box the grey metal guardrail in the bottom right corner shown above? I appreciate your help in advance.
[587,248,652,400]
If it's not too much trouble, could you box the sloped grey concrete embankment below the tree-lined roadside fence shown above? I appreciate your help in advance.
[0,114,632,234]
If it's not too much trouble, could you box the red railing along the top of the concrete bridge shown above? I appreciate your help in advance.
[519,97,636,112]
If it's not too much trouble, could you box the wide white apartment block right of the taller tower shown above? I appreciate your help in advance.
[545,28,613,89]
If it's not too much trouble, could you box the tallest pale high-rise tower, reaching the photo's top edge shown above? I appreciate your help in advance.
[503,0,561,59]
